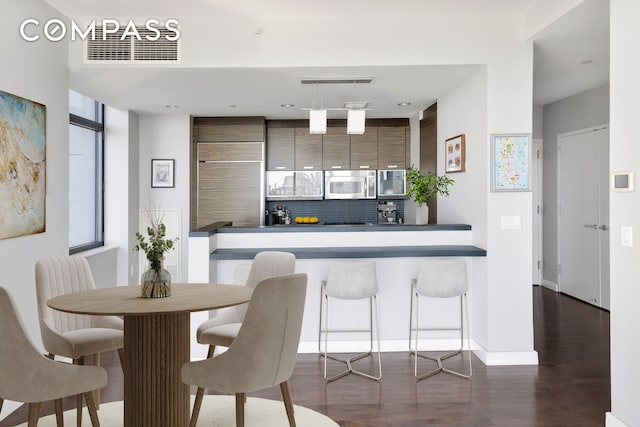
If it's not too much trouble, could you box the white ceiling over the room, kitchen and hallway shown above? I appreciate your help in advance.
[48,0,609,119]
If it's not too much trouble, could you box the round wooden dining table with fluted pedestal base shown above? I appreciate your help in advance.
[47,283,253,427]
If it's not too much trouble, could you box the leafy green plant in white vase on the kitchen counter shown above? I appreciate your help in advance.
[407,165,455,224]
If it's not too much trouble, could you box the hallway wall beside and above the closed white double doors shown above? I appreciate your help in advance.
[542,84,609,285]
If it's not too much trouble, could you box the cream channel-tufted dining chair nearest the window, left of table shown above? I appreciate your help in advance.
[36,255,124,418]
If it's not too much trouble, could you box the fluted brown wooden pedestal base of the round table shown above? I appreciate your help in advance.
[124,312,190,427]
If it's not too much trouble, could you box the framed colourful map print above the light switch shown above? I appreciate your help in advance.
[491,133,531,191]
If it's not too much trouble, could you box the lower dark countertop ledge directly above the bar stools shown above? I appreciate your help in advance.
[210,245,487,261]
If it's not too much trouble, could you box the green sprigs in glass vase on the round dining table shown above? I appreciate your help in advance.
[133,218,178,298]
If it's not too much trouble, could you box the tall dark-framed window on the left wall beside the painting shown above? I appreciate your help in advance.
[69,90,104,254]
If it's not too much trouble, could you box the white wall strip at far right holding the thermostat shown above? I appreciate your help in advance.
[607,0,640,427]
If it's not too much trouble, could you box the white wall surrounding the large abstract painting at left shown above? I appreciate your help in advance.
[0,0,69,418]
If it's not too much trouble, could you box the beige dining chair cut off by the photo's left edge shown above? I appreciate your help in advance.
[0,287,107,427]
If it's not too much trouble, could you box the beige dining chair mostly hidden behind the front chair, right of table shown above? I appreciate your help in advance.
[192,251,296,419]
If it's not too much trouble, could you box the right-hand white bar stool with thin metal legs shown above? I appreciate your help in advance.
[409,258,473,380]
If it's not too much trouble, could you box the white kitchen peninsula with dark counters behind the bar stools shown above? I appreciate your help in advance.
[189,223,486,357]
